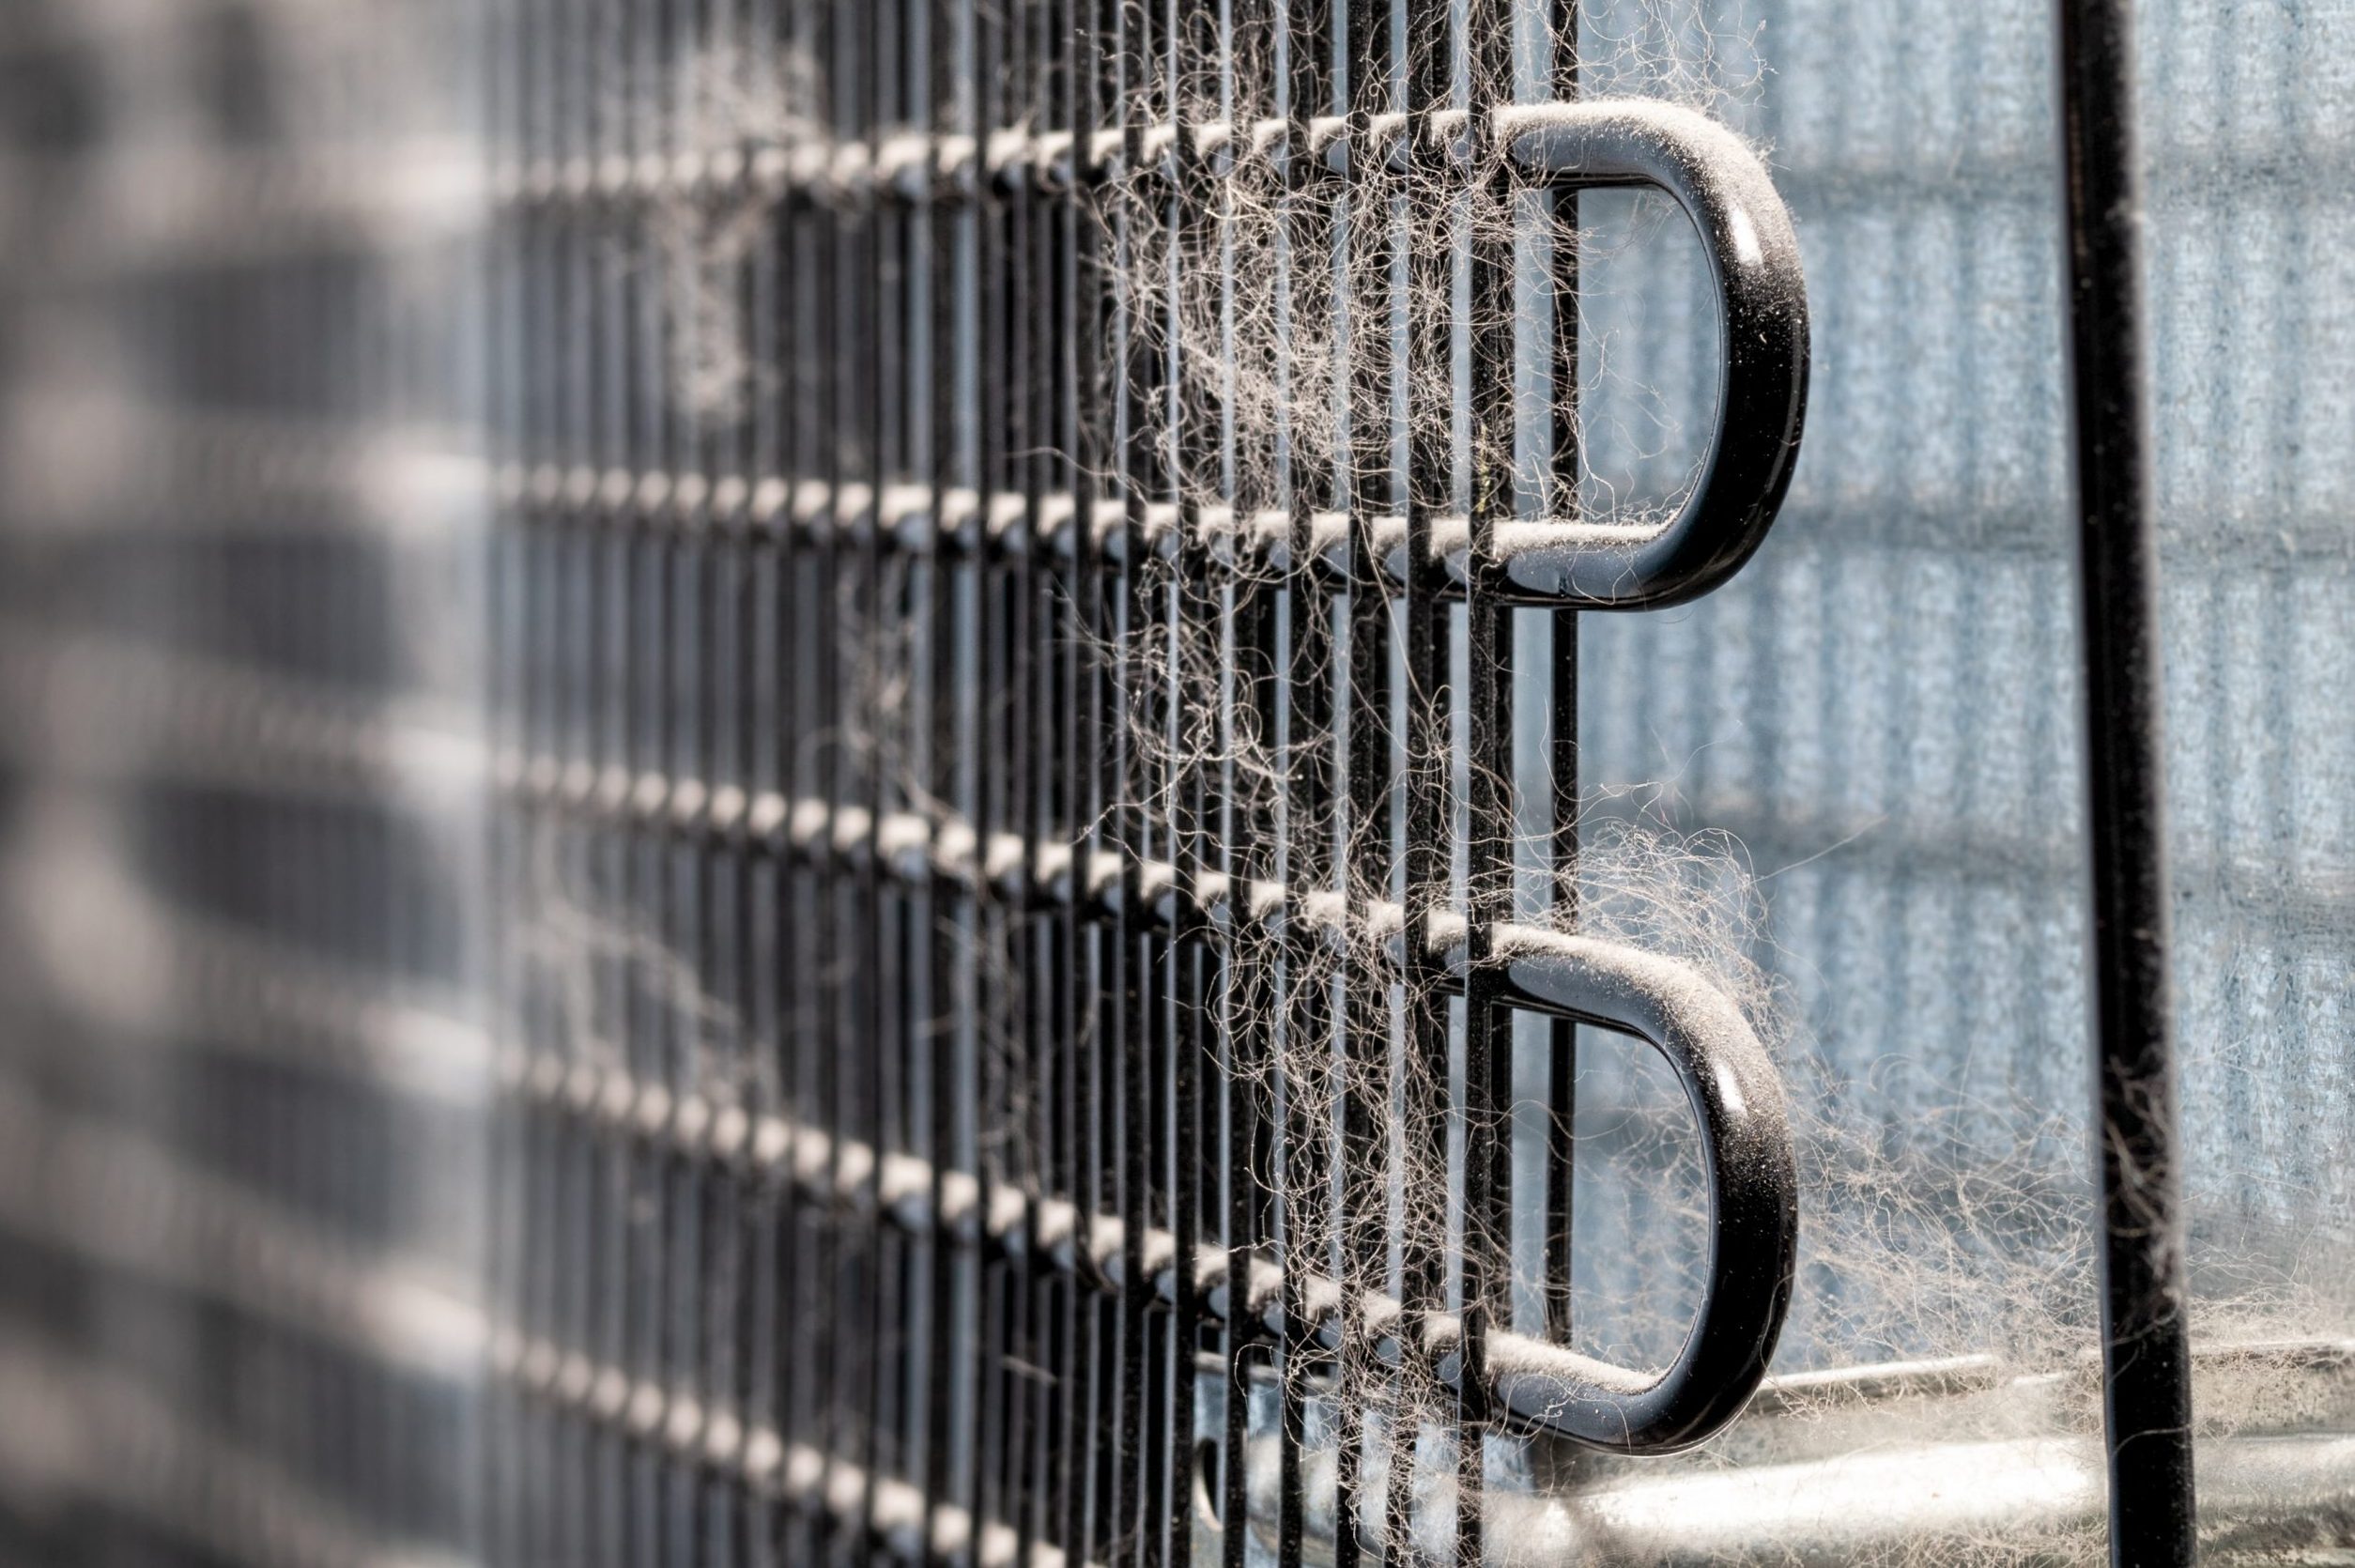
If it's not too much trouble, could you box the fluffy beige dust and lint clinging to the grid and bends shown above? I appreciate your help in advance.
[520,3,2346,1560]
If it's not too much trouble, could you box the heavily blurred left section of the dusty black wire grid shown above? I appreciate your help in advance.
[0,0,487,1568]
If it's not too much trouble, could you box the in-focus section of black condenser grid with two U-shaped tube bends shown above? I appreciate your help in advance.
[478,3,1807,1563]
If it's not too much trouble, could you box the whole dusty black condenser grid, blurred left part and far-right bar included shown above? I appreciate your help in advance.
[0,0,2232,1563]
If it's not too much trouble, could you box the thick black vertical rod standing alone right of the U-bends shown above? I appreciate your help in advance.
[2058,0,2197,1568]
